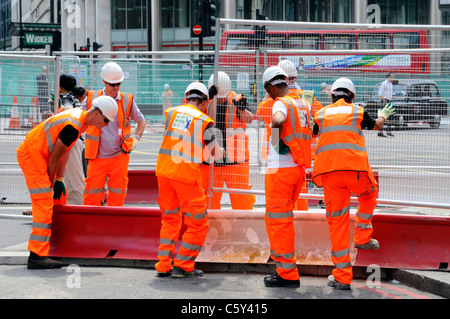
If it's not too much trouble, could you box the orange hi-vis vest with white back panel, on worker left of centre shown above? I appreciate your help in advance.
[156,104,214,185]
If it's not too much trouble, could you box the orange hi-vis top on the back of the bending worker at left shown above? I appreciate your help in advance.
[23,108,87,172]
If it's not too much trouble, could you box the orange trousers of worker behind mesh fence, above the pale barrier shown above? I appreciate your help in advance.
[200,162,255,210]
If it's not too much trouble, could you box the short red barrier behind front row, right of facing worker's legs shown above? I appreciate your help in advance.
[125,170,158,204]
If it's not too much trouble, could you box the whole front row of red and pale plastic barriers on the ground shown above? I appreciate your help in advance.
[50,206,450,270]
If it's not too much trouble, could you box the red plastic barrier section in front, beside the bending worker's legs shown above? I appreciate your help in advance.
[50,206,161,260]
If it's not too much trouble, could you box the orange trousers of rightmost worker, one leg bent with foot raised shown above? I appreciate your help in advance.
[322,172,378,284]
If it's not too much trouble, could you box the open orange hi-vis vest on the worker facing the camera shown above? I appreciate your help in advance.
[85,90,133,160]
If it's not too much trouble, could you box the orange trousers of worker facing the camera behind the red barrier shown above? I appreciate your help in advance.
[83,153,130,206]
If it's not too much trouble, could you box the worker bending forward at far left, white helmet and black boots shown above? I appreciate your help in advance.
[17,96,117,269]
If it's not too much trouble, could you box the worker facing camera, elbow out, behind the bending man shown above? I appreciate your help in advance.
[81,62,146,206]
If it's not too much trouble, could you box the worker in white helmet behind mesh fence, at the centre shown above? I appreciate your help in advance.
[201,71,255,210]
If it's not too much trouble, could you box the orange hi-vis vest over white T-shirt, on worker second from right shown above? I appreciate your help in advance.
[275,93,311,168]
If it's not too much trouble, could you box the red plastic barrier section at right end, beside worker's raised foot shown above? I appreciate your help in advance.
[355,214,450,270]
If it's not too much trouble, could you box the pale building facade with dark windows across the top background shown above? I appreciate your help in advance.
[5,0,450,51]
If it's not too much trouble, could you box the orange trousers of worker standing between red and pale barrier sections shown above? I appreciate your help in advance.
[155,176,209,272]
